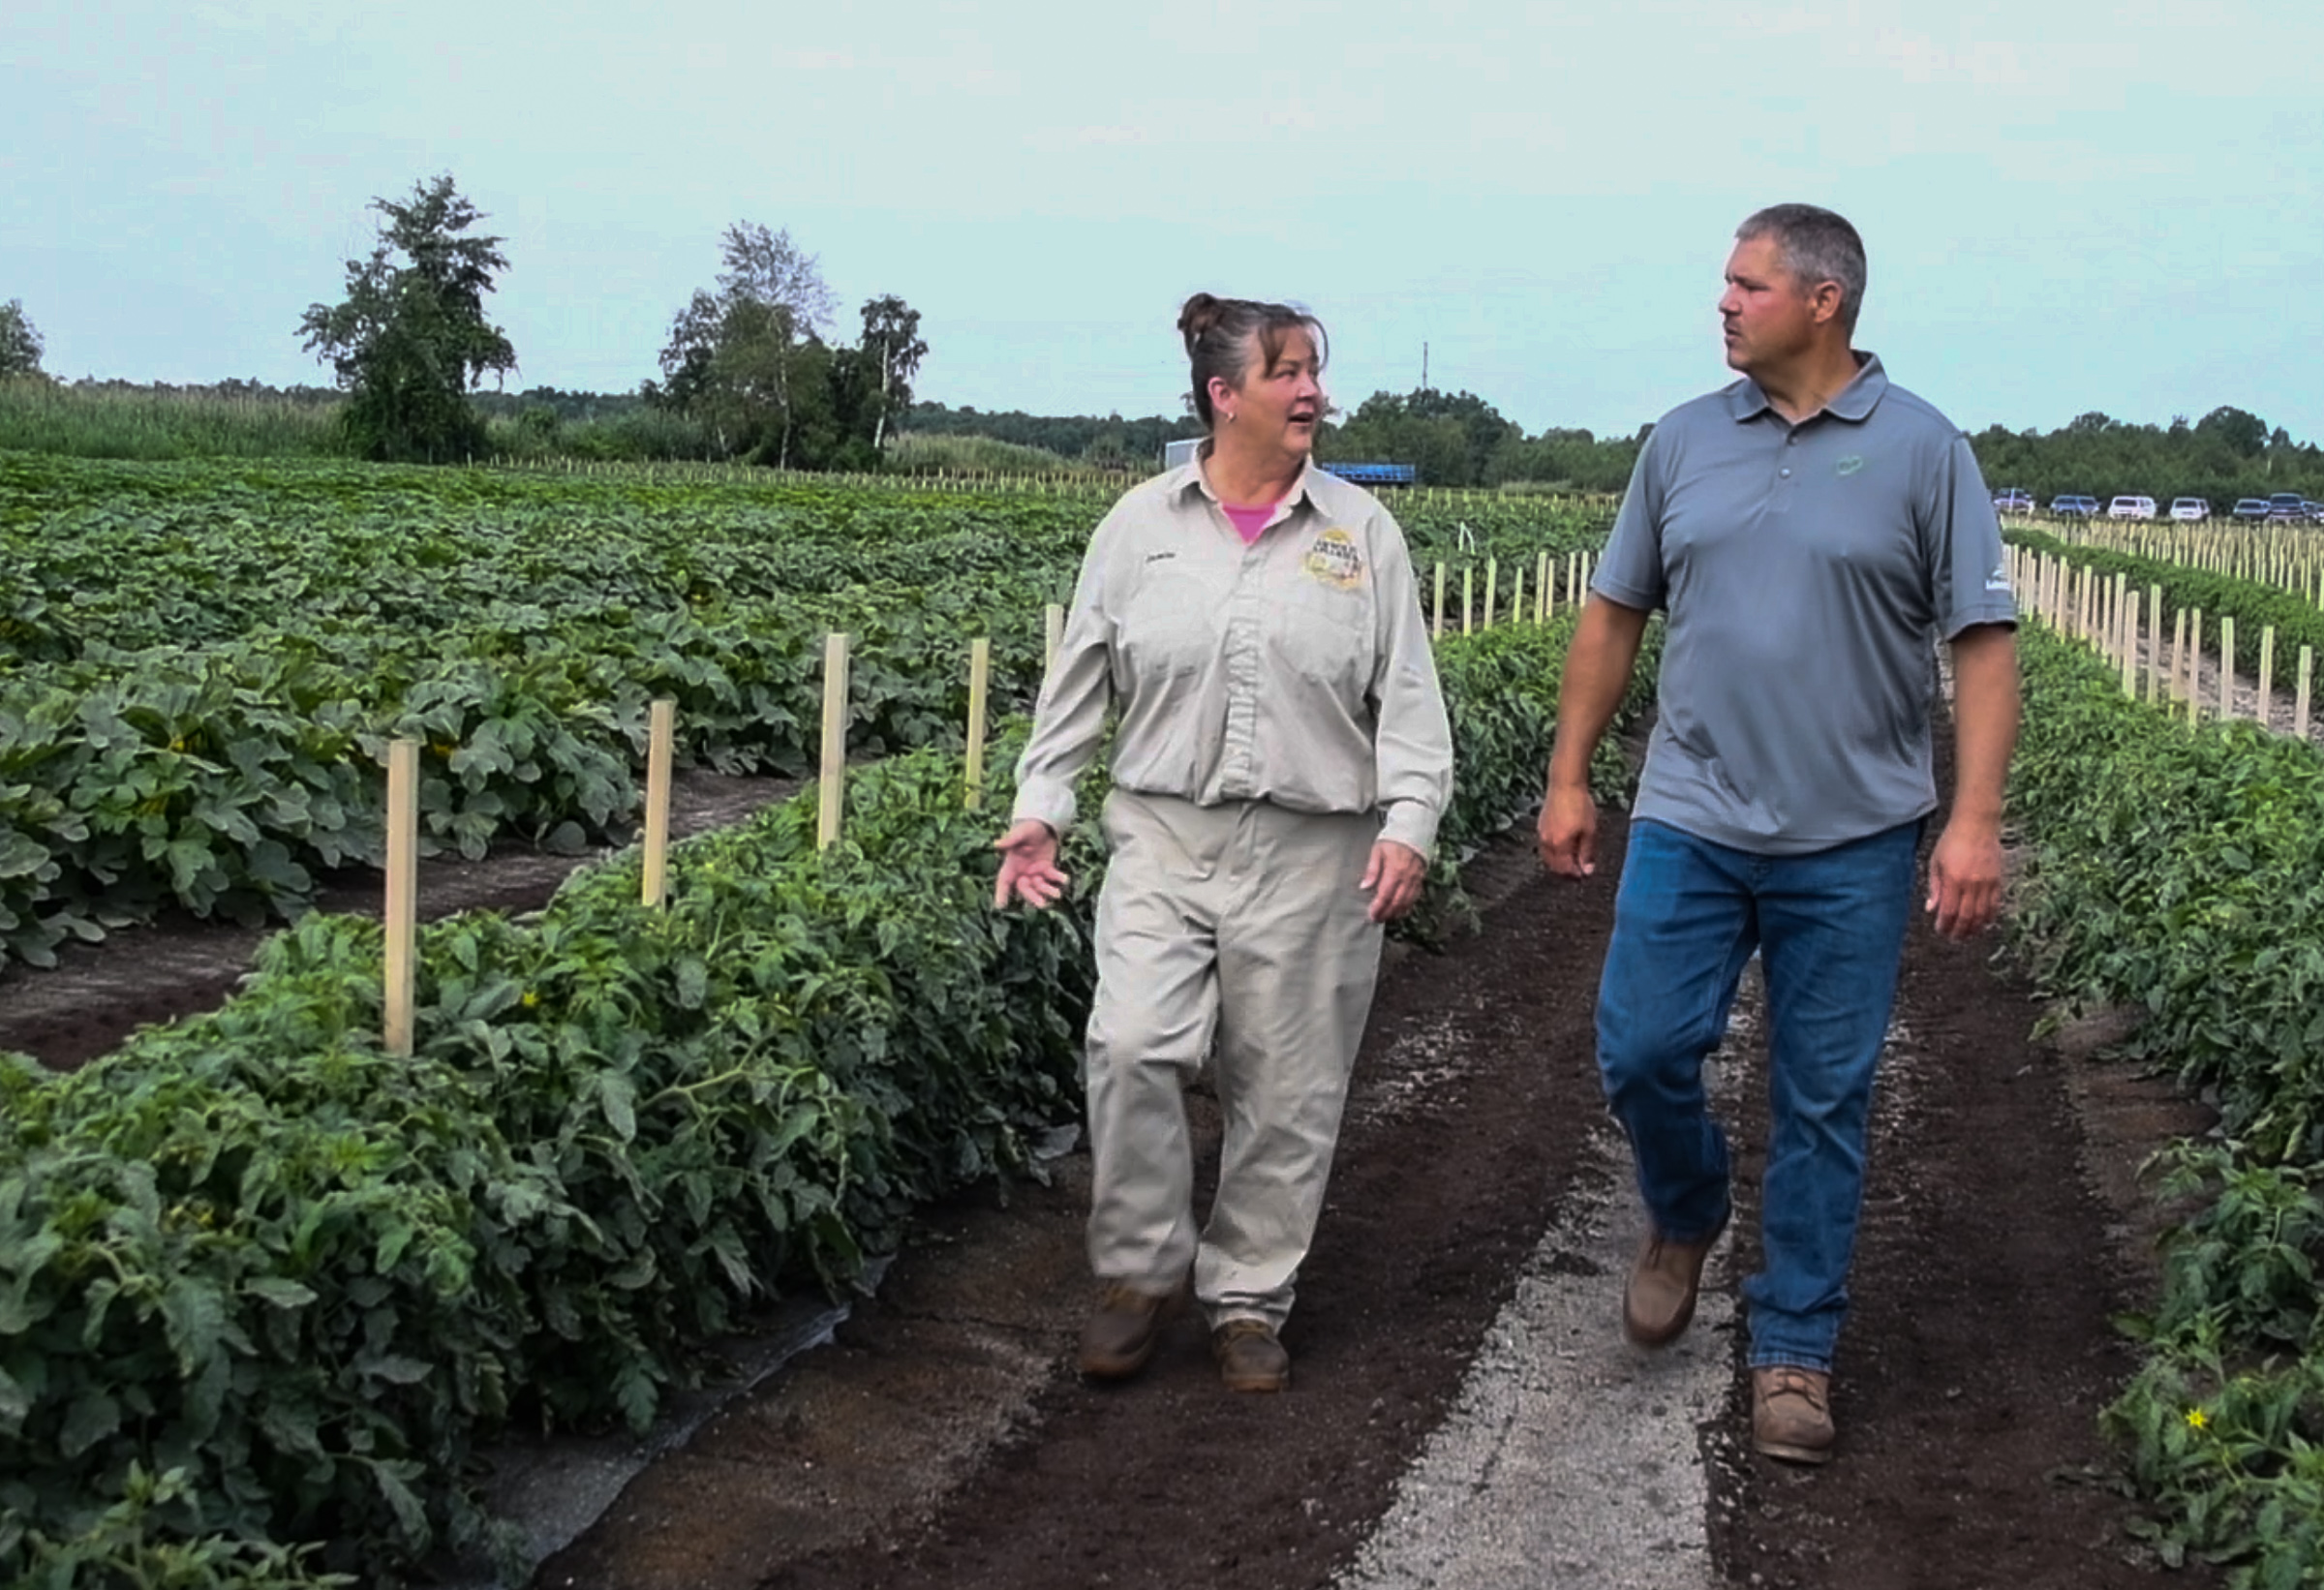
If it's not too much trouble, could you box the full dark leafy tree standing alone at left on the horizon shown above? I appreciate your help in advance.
[300,172,516,463]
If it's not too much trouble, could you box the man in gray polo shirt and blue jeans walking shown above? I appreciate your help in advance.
[1541,204,2017,1462]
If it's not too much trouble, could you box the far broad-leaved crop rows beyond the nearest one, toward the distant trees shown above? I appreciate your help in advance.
[0,453,1605,679]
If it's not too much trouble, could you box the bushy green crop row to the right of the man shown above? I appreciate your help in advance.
[2012,627,2324,1590]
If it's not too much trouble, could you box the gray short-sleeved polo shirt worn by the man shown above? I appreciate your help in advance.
[1590,353,2017,855]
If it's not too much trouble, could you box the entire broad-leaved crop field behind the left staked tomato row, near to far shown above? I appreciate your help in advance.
[0,445,1604,963]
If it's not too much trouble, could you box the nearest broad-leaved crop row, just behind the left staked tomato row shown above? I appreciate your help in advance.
[0,579,1064,964]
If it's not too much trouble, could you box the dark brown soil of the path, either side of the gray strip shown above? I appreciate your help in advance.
[536,825,2203,1590]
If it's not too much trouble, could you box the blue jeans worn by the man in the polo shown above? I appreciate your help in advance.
[1597,820,1922,1371]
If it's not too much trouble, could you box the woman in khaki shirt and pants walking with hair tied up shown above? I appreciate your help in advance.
[993,292,1452,1391]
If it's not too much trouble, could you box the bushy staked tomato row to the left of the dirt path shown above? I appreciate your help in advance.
[0,621,1645,1590]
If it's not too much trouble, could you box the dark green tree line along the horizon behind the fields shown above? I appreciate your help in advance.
[0,188,2324,497]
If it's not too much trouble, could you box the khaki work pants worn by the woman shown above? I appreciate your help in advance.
[1086,790,1381,1325]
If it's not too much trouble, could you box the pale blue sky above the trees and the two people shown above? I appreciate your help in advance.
[0,0,2324,440]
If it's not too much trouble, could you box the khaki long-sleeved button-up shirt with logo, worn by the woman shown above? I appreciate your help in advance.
[1016,463,1452,855]
